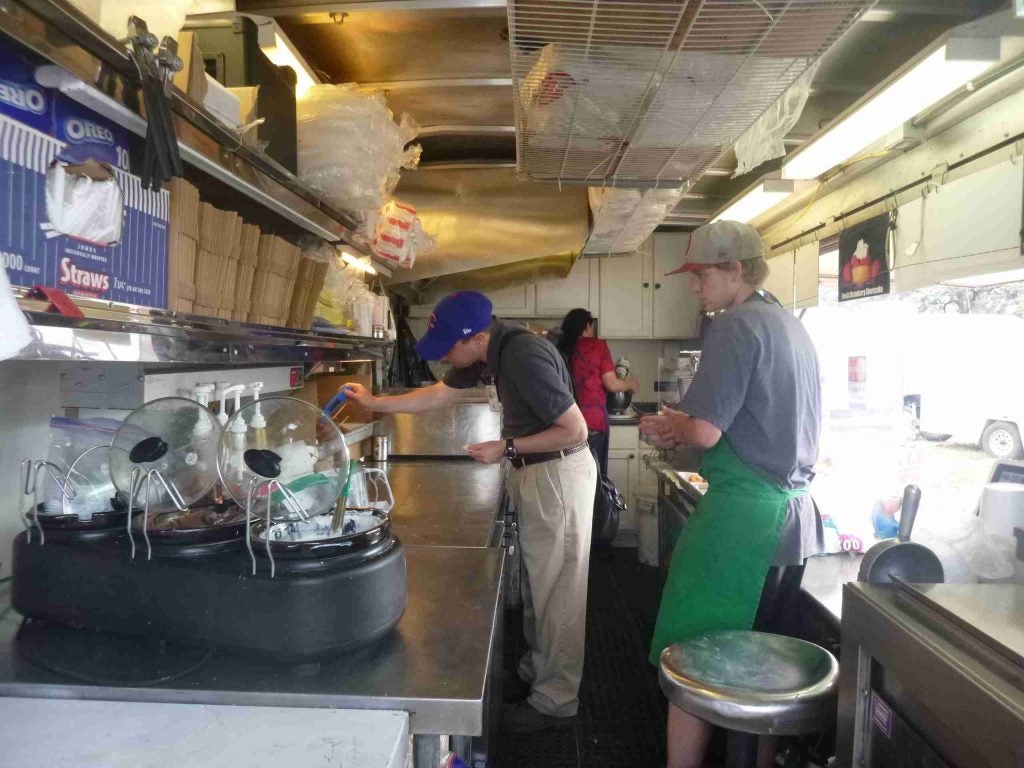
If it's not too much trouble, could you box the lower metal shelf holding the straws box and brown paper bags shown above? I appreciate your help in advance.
[15,298,391,366]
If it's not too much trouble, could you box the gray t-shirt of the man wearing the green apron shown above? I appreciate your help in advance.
[681,294,824,565]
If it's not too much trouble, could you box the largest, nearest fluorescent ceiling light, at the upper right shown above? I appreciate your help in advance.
[782,38,999,179]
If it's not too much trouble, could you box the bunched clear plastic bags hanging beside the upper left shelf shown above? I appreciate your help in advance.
[298,88,421,222]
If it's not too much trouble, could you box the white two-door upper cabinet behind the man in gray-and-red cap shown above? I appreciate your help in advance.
[596,232,700,339]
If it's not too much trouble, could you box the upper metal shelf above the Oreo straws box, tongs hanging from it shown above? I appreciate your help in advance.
[0,0,380,262]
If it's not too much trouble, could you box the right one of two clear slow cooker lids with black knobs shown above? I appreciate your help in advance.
[217,397,349,520]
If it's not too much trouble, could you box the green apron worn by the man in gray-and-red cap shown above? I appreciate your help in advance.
[650,436,807,667]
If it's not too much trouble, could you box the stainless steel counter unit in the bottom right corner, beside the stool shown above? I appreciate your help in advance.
[836,584,1024,768]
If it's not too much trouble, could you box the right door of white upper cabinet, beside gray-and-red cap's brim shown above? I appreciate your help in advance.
[651,232,700,339]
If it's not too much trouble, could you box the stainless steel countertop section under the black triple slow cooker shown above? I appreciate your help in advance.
[0,548,505,736]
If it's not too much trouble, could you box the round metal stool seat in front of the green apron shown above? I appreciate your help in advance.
[658,631,839,735]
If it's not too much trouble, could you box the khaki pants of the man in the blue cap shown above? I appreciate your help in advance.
[511,451,597,716]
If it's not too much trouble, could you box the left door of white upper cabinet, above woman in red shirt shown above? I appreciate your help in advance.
[597,250,651,339]
